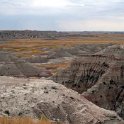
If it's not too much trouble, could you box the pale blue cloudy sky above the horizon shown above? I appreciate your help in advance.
[0,0,124,31]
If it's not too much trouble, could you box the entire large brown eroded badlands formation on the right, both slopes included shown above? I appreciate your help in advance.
[53,45,124,118]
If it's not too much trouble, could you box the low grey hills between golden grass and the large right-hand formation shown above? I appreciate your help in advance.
[48,44,111,59]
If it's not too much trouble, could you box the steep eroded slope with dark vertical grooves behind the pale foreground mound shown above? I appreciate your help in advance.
[53,55,115,93]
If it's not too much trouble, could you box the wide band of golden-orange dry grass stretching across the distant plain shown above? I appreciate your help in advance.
[0,35,124,57]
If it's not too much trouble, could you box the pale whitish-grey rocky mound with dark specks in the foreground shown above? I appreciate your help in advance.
[0,77,124,124]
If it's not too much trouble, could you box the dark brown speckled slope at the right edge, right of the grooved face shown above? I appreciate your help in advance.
[83,61,124,118]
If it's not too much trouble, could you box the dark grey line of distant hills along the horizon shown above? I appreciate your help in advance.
[0,30,124,41]
